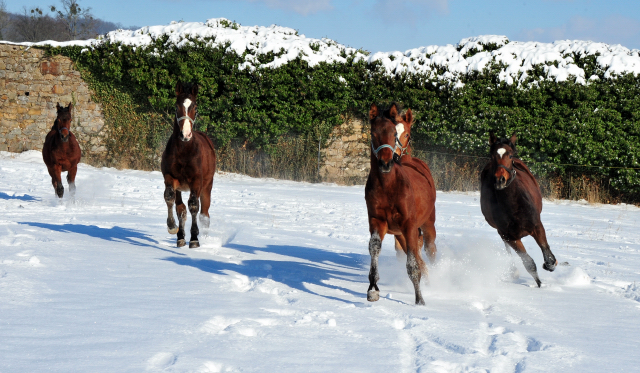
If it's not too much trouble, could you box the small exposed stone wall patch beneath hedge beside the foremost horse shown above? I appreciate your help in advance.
[320,117,371,184]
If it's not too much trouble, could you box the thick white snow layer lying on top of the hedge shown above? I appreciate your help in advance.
[17,18,640,84]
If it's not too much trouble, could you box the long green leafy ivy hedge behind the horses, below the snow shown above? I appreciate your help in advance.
[42,37,640,196]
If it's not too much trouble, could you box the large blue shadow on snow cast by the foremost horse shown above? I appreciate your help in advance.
[163,244,366,304]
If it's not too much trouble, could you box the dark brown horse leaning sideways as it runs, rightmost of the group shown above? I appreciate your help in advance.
[480,133,558,287]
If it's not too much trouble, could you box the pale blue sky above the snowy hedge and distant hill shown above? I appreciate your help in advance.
[5,0,640,52]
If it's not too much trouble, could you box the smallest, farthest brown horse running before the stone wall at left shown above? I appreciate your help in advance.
[42,103,82,198]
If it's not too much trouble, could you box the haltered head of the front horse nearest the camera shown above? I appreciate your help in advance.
[369,104,402,174]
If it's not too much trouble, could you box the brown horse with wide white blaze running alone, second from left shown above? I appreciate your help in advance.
[160,82,216,248]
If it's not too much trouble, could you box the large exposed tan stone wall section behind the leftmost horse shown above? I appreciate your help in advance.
[0,43,106,157]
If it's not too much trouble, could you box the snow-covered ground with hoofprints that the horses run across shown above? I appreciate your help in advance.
[0,151,640,373]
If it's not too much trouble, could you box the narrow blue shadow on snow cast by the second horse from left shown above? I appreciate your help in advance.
[19,222,185,255]
